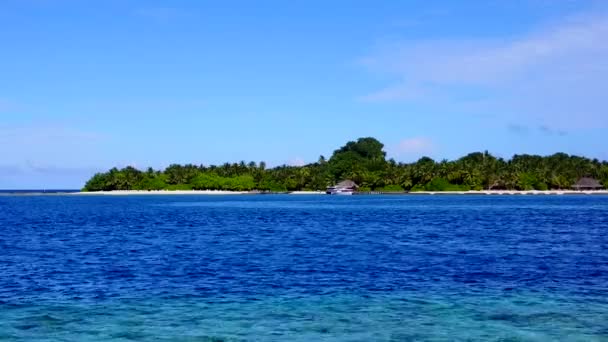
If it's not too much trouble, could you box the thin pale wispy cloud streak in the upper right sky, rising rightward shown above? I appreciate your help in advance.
[364,16,608,85]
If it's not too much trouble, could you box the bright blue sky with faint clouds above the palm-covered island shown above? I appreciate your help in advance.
[0,0,608,189]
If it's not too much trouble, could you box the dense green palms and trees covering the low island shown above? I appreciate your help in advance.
[83,138,608,191]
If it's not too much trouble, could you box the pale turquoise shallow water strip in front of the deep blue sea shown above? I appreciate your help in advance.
[0,294,608,341]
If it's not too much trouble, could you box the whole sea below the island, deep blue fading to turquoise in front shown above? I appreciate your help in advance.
[0,195,608,341]
